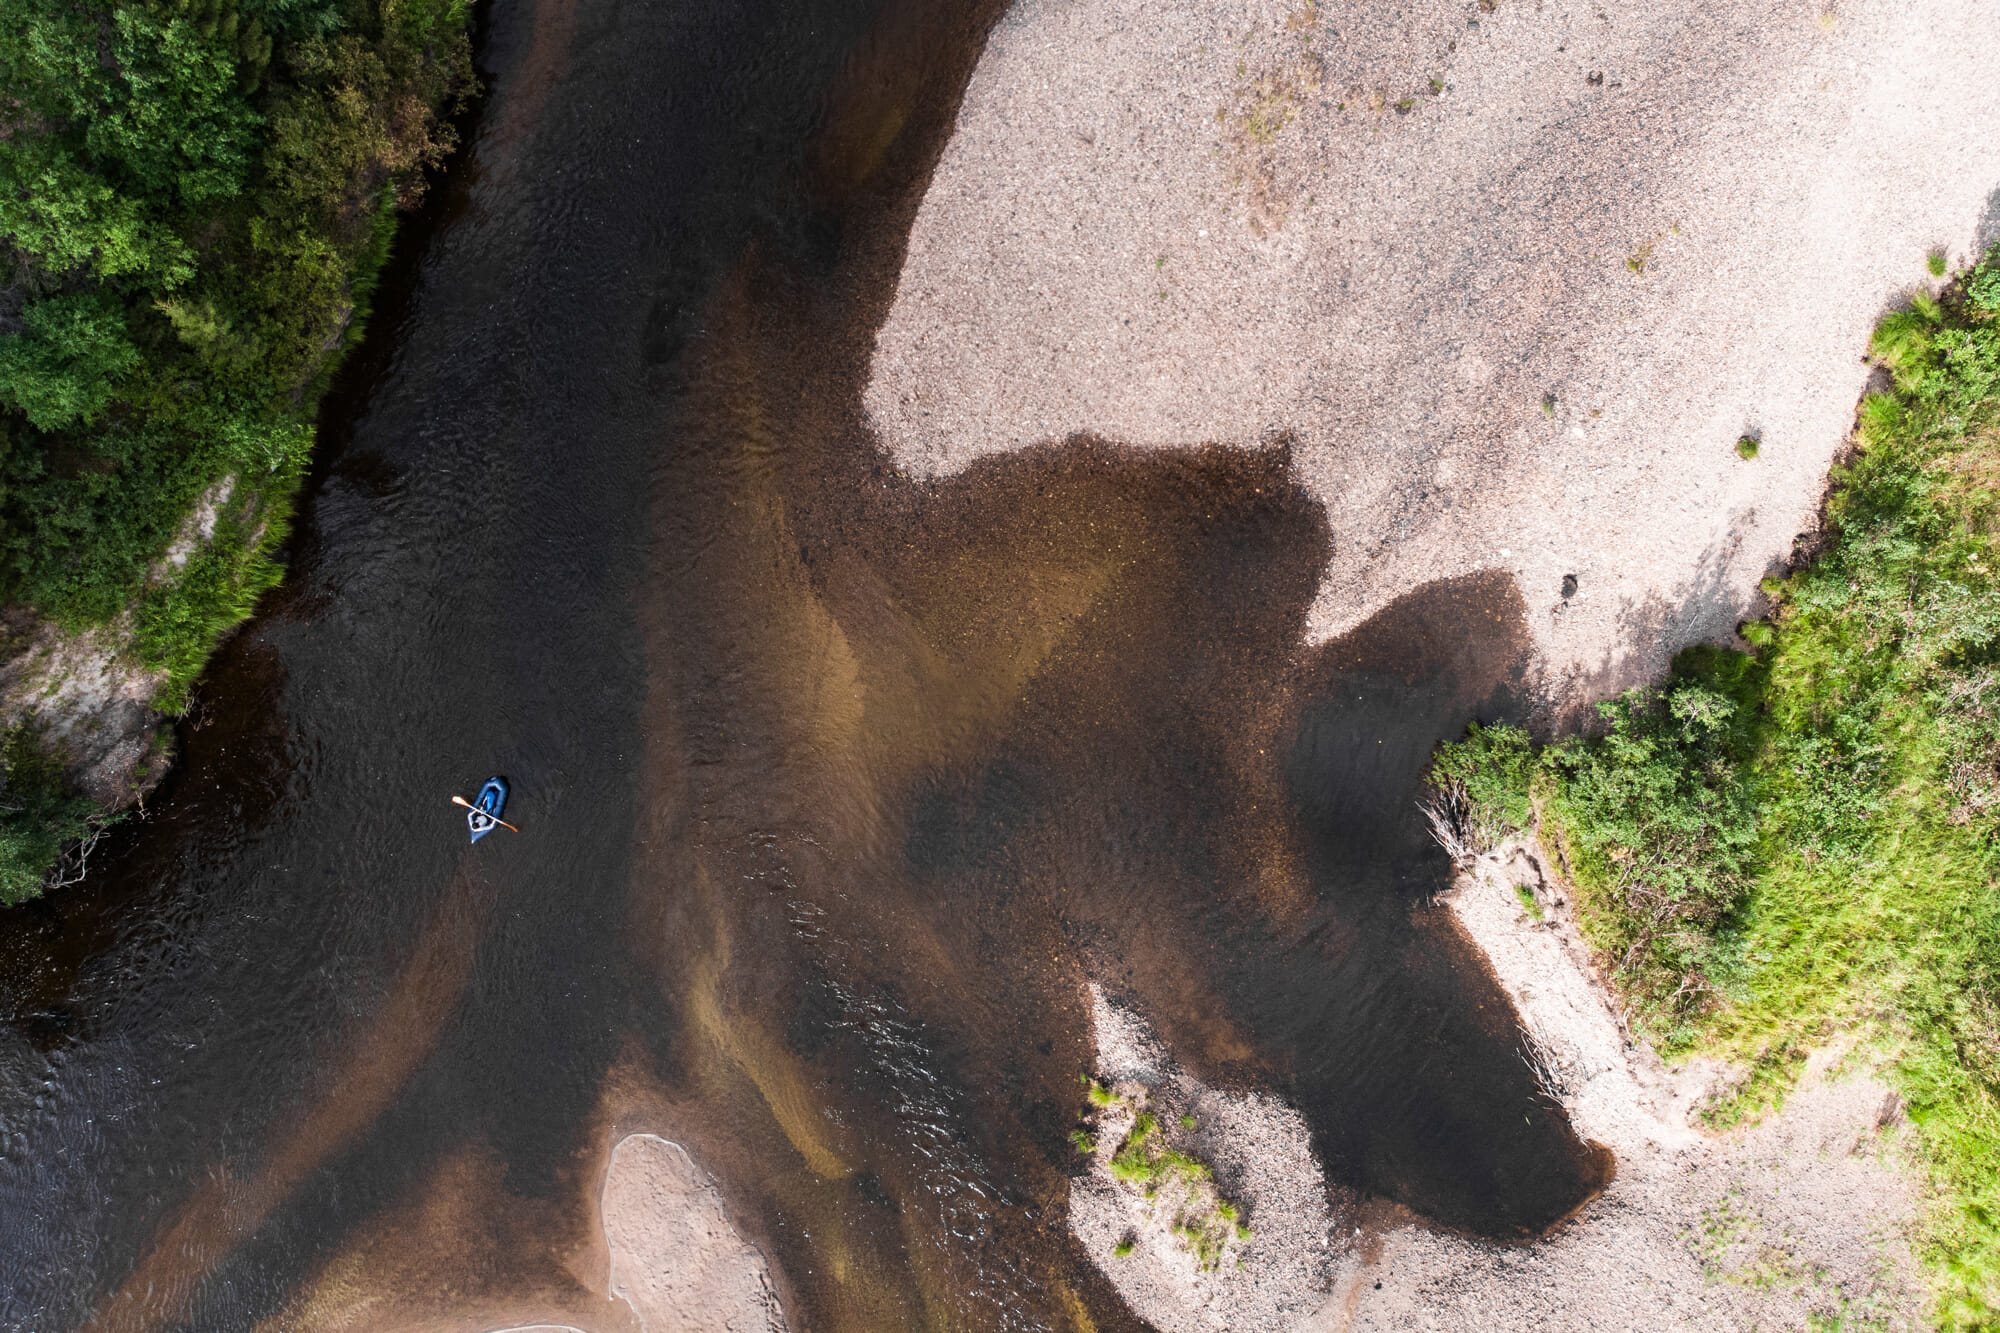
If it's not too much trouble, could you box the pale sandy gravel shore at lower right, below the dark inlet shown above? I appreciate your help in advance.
[1070,845,1930,1333]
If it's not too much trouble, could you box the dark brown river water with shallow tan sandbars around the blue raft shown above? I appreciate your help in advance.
[0,0,1608,1331]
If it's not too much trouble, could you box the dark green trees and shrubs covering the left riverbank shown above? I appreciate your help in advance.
[0,0,476,905]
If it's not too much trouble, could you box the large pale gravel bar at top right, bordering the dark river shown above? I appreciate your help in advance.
[866,0,2000,689]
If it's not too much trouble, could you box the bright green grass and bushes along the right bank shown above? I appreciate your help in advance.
[1430,246,2000,1329]
